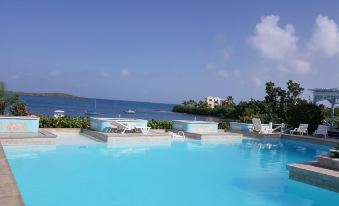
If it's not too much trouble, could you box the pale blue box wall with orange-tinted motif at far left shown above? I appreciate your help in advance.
[0,116,40,133]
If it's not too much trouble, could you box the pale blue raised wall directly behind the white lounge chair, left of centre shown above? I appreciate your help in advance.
[90,117,148,132]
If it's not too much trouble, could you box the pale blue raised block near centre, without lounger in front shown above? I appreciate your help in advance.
[172,120,218,134]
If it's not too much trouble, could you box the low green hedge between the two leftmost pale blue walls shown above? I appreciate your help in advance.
[39,116,89,129]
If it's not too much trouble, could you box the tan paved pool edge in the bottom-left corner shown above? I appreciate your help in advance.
[0,142,25,206]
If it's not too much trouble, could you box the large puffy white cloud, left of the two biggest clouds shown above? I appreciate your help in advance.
[248,15,312,74]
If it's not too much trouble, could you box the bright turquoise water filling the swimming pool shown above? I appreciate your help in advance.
[5,139,339,206]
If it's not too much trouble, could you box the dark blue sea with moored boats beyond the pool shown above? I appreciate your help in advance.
[20,96,217,121]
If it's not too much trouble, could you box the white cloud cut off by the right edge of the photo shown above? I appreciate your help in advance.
[310,15,339,57]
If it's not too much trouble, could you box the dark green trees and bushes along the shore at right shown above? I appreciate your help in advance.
[172,80,326,133]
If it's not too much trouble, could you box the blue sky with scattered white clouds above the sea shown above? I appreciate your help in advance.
[0,0,339,103]
